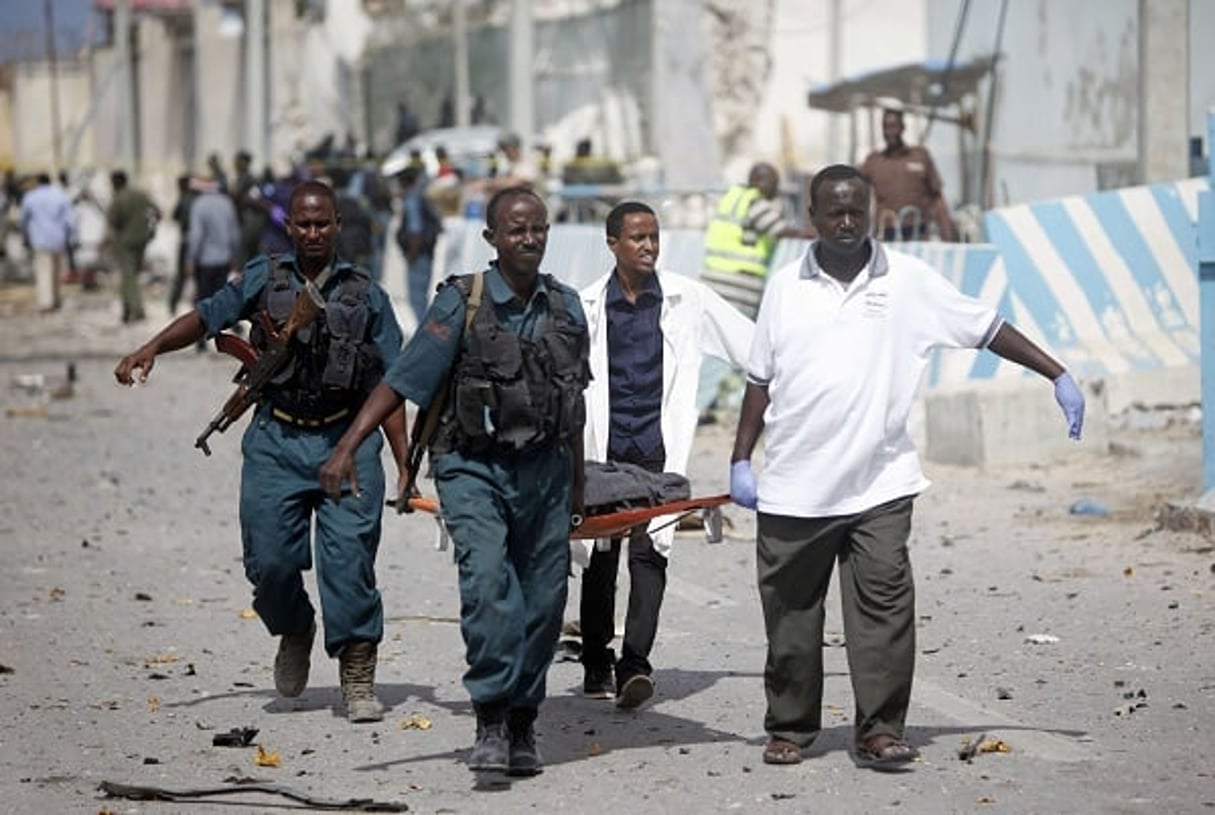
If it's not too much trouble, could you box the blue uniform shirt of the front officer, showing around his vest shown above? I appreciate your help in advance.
[384,262,587,408]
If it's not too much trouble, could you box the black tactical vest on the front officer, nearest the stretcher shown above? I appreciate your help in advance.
[430,275,590,455]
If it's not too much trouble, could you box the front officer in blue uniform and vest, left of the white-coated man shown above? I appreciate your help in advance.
[321,187,589,775]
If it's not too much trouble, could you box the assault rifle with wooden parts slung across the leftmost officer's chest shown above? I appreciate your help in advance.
[194,285,324,455]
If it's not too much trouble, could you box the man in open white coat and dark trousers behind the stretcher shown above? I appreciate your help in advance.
[575,202,755,708]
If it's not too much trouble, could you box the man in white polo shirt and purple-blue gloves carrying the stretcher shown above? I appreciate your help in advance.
[730,164,1084,765]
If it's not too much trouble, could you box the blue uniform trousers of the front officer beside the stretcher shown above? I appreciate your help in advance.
[435,446,572,708]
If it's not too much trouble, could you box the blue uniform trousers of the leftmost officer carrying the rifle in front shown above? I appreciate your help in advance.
[241,404,384,657]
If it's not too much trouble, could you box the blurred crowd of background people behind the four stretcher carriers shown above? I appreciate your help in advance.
[0,101,959,322]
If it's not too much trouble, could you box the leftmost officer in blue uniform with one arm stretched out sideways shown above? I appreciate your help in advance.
[114,181,406,721]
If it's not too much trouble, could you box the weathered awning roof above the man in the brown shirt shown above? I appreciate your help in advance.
[807,56,996,113]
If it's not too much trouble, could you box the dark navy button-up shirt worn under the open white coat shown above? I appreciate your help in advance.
[604,275,662,460]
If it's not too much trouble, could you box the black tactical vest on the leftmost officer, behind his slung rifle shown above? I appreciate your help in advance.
[249,257,384,419]
